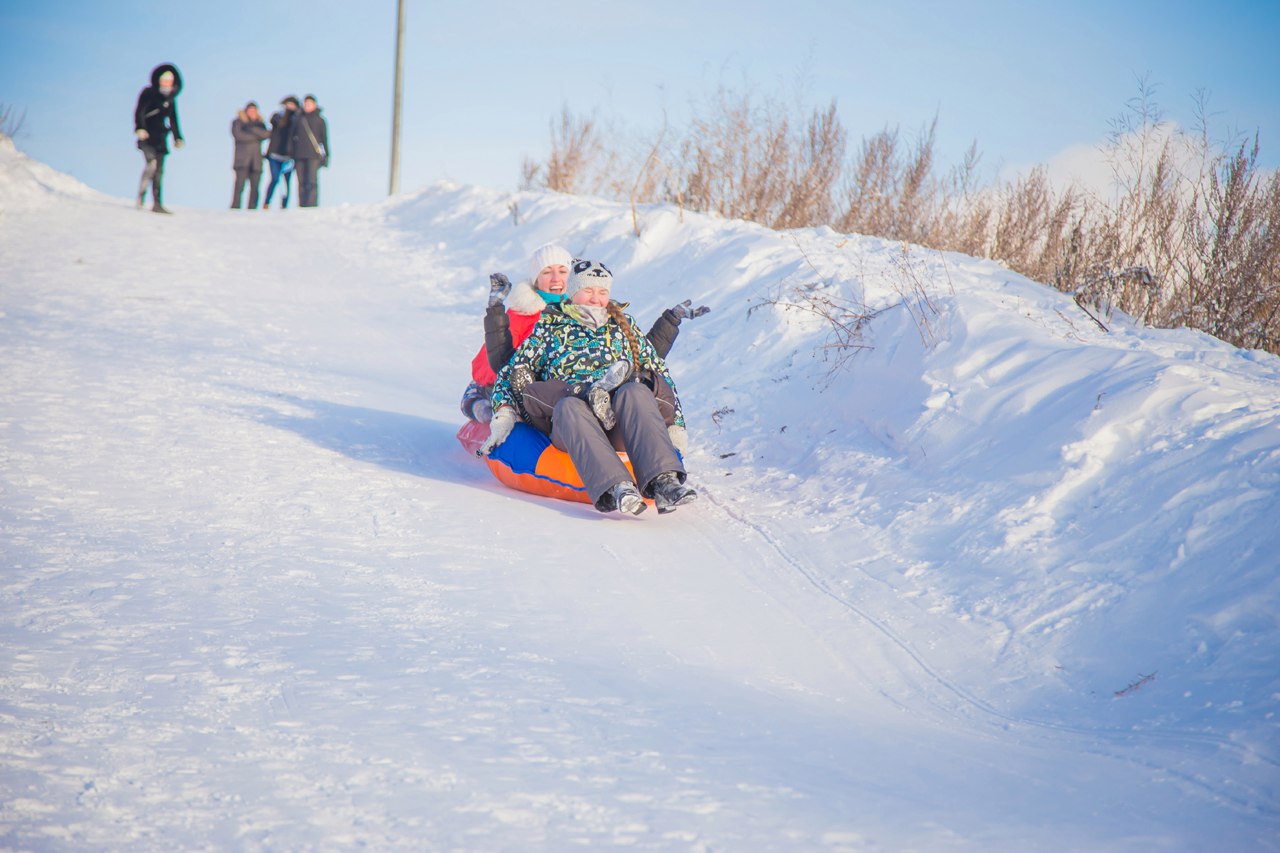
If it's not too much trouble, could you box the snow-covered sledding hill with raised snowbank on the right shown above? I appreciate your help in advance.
[0,146,1280,850]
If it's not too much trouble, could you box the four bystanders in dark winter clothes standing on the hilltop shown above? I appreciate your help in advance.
[133,63,329,214]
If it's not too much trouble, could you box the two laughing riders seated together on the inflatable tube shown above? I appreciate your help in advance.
[462,243,710,515]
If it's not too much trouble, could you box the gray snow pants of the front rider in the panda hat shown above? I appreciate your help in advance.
[525,382,685,505]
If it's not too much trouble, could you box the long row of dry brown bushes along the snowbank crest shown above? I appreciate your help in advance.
[522,82,1280,352]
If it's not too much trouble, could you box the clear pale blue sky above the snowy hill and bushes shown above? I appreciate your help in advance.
[0,0,1280,207]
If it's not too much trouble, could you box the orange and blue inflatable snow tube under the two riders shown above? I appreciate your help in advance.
[458,420,645,503]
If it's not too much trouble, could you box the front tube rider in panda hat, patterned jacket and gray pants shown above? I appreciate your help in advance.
[477,260,698,515]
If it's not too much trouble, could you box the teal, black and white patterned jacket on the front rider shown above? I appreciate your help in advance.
[492,302,685,427]
